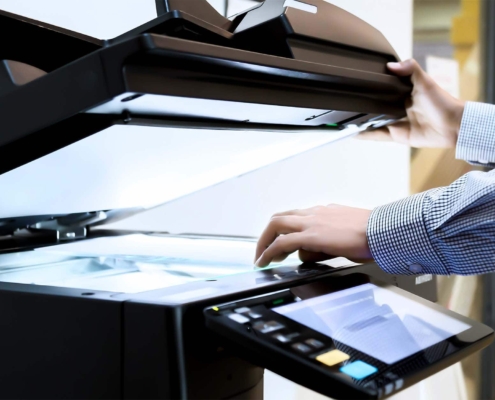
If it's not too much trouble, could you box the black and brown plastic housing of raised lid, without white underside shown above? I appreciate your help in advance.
[0,0,411,178]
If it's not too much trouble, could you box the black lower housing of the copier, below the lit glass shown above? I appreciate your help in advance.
[0,256,436,399]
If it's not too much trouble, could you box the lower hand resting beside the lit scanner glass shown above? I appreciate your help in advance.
[255,204,372,267]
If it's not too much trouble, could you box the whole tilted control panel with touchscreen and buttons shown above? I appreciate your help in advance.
[204,274,492,399]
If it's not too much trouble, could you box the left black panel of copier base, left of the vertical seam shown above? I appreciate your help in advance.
[0,284,121,399]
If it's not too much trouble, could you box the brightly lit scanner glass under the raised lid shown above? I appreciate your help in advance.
[0,234,299,293]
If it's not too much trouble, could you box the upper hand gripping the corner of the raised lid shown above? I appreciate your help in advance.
[358,60,464,148]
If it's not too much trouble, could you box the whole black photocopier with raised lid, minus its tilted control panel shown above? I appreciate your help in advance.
[0,0,491,399]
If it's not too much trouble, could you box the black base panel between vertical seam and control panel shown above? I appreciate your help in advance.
[123,300,263,400]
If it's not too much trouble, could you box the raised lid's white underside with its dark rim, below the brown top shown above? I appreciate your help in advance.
[0,0,410,237]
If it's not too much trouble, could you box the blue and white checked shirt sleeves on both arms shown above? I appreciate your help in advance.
[367,103,495,275]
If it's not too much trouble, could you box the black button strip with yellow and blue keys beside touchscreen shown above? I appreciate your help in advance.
[207,291,404,398]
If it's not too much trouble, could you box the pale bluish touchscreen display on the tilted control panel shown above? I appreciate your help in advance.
[272,283,471,364]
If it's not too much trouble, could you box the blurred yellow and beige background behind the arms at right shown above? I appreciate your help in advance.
[411,0,486,399]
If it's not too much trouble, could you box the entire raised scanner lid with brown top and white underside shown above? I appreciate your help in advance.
[0,0,411,247]
